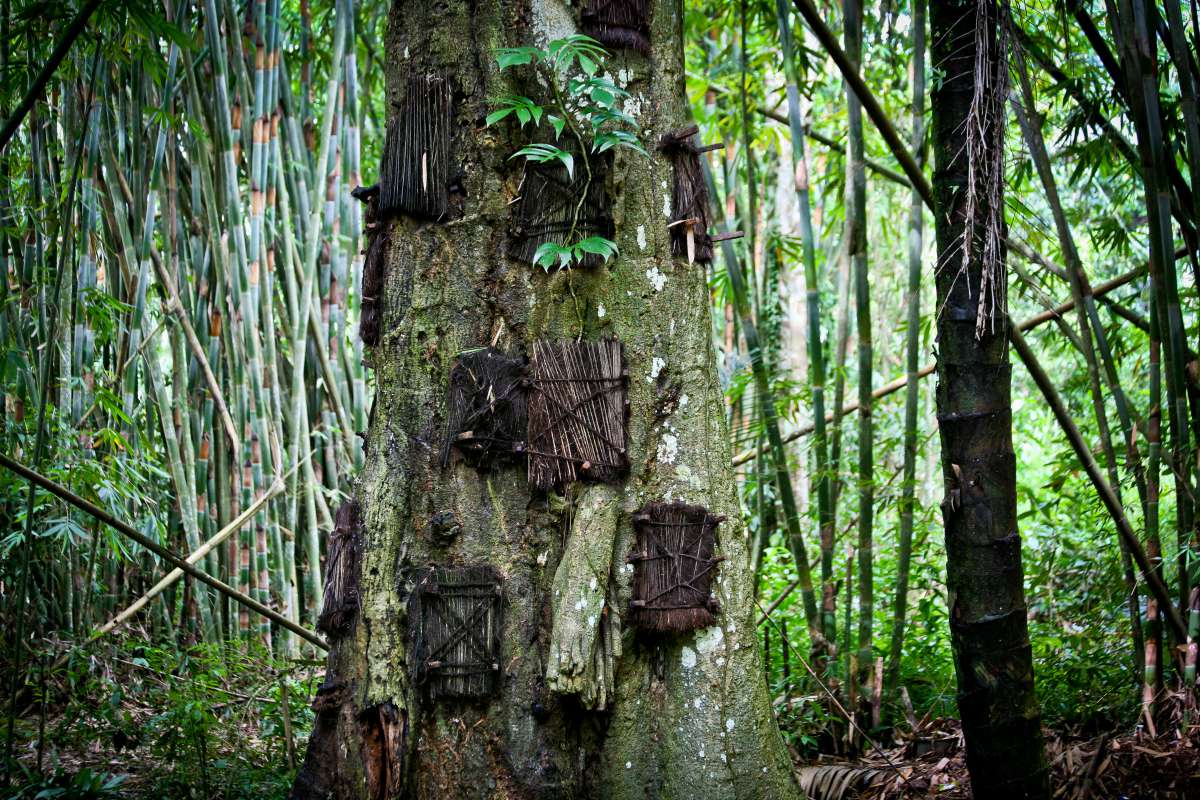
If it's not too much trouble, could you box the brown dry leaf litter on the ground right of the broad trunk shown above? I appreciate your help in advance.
[799,718,1200,800]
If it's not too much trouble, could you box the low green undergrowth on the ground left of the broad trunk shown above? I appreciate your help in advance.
[0,638,320,800]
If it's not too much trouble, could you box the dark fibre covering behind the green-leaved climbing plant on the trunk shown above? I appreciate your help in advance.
[508,155,614,266]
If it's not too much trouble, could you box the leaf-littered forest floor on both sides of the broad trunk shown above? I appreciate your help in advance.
[0,637,1200,800]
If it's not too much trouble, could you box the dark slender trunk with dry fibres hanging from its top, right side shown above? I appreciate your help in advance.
[930,0,1049,800]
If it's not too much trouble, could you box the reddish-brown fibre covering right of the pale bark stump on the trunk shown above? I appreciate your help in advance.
[628,503,725,633]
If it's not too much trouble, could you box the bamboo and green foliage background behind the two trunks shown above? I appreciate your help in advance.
[0,0,1200,796]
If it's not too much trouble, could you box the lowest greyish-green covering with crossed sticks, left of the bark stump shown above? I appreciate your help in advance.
[409,565,503,699]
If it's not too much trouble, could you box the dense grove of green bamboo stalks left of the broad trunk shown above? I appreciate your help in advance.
[0,0,382,671]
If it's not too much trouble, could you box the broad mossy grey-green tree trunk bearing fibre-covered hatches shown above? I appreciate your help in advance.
[294,0,799,799]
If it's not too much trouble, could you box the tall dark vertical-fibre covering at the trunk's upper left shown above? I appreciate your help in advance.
[379,76,451,219]
